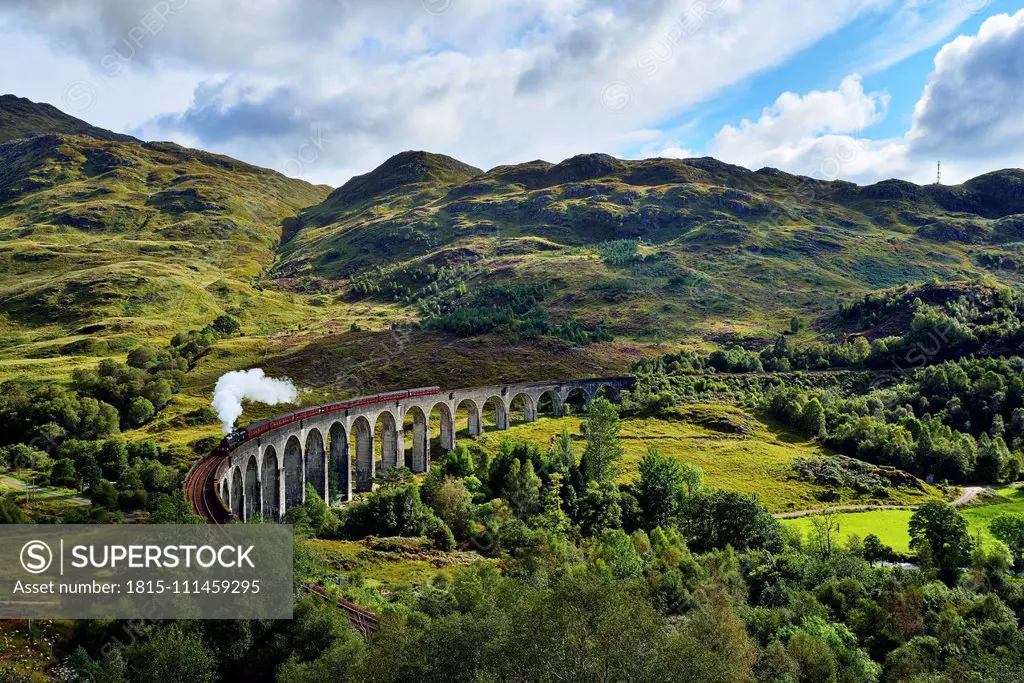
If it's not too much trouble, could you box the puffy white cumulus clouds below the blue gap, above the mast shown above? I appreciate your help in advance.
[708,10,1024,187]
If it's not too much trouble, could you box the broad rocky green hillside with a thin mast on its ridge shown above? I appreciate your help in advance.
[273,153,1024,356]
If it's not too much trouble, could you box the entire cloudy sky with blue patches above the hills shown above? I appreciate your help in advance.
[0,0,1024,185]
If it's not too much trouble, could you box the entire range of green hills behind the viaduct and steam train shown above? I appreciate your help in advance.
[0,96,1024,442]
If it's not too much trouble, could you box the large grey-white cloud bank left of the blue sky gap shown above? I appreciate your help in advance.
[0,0,929,183]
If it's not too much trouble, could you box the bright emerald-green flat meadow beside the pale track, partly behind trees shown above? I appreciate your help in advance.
[782,487,1024,552]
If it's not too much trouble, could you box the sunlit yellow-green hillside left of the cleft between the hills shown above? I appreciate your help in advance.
[0,98,327,368]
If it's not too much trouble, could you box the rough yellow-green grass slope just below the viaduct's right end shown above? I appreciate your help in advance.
[480,404,938,512]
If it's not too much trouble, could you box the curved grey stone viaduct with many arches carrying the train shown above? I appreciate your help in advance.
[215,377,634,521]
